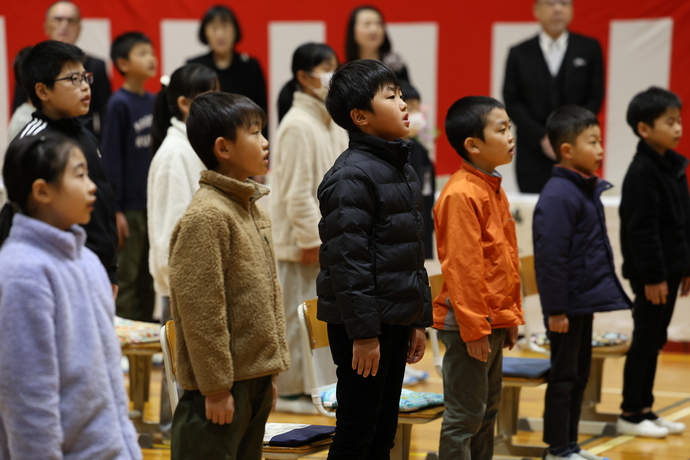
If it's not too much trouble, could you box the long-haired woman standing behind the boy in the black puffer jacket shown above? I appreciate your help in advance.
[345,5,410,81]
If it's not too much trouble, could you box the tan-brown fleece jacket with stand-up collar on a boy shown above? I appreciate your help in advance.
[169,171,290,394]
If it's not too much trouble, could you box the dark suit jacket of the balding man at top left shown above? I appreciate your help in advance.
[12,56,112,140]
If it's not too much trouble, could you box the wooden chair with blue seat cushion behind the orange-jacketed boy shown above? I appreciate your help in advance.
[428,275,551,460]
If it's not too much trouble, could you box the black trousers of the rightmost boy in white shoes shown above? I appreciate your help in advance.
[621,275,681,413]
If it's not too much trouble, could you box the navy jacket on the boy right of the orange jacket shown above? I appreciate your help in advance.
[532,167,632,317]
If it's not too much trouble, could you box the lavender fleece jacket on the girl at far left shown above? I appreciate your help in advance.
[0,214,141,460]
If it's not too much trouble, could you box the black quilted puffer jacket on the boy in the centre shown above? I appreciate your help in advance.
[316,133,431,339]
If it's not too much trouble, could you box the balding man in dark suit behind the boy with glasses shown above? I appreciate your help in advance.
[12,1,112,139]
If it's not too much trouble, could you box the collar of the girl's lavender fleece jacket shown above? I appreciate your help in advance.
[10,213,86,260]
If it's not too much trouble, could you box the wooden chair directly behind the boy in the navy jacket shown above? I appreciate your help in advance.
[520,255,630,436]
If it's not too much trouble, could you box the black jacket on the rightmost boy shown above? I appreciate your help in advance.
[620,141,690,284]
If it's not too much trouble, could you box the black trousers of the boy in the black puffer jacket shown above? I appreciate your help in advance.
[328,324,410,460]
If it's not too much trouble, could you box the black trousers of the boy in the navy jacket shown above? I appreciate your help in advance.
[544,314,593,449]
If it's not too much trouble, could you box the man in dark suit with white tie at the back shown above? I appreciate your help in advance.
[503,0,604,193]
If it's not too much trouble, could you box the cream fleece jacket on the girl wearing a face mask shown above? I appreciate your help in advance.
[270,91,348,262]
